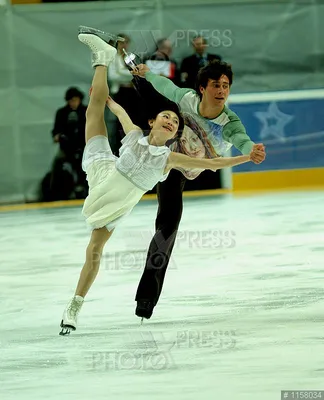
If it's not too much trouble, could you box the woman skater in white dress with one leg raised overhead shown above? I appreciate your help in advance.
[60,30,251,335]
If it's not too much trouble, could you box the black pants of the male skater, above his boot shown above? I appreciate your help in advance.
[135,170,186,306]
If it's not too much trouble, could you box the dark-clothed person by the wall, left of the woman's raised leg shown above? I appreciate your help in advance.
[50,87,87,200]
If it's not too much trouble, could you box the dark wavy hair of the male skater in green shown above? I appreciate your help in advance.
[196,60,233,98]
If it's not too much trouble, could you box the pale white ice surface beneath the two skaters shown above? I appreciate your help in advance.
[0,191,324,400]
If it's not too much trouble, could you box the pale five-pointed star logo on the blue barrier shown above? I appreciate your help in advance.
[254,102,294,142]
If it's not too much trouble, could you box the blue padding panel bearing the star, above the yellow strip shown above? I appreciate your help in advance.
[229,98,324,172]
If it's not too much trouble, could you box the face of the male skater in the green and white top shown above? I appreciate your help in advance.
[200,75,230,107]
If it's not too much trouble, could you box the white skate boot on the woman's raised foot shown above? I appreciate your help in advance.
[78,33,117,67]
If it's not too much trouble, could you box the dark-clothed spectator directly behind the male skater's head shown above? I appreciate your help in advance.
[180,36,221,89]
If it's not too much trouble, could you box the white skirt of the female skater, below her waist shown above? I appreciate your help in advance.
[82,135,145,231]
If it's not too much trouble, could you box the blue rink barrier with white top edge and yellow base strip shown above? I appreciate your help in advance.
[227,89,324,191]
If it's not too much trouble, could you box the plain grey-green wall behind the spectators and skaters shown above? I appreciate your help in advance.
[0,0,324,202]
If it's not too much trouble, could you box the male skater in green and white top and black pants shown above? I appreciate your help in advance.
[132,60,265,319]
